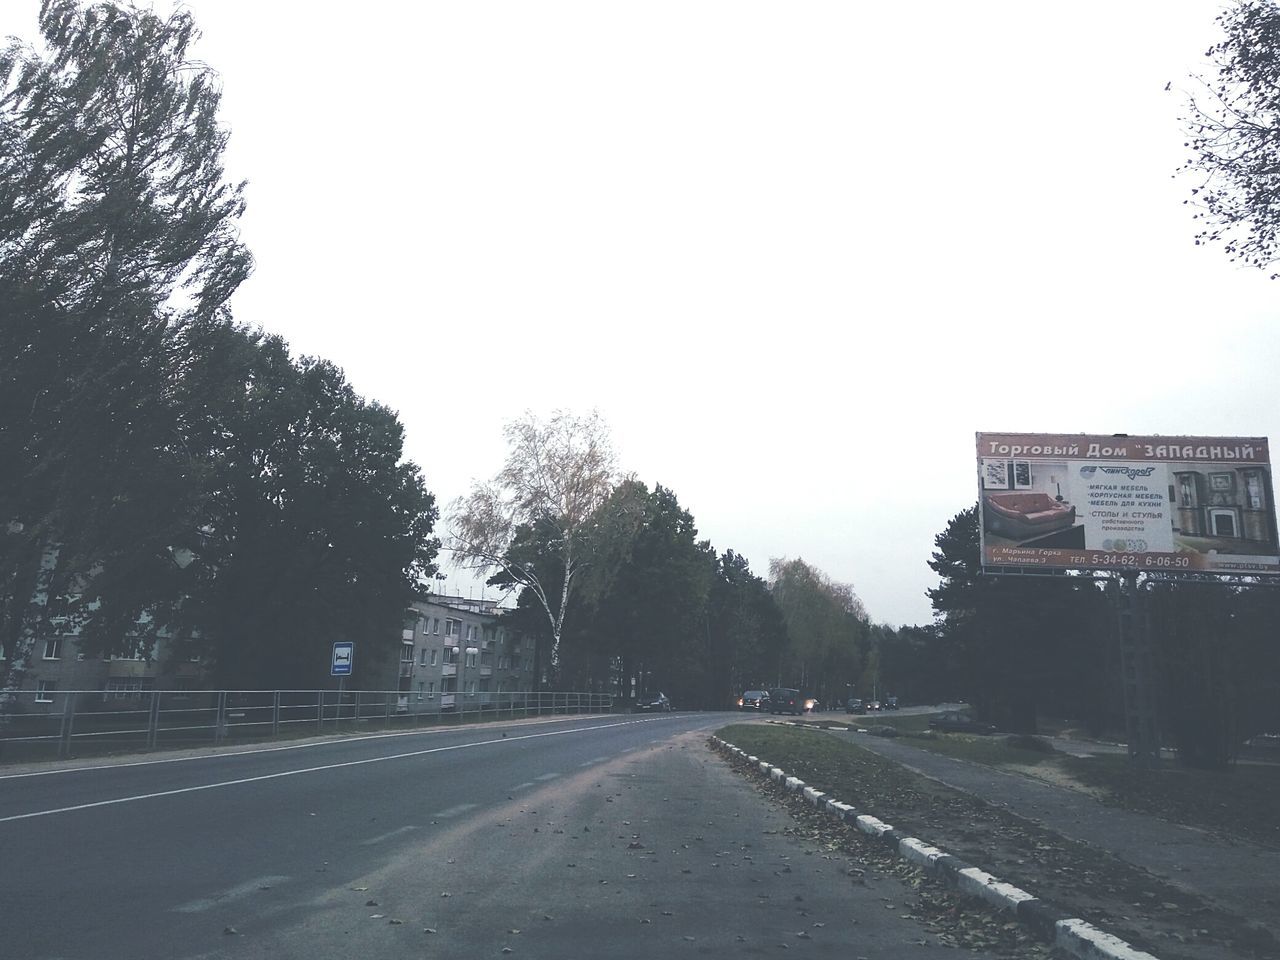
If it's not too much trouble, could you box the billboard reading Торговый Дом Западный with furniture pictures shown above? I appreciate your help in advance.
[978,433,1280,575]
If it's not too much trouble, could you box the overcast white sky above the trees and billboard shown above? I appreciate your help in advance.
[0,0,1280,623]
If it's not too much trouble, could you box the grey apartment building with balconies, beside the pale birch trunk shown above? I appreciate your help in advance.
[394,595,536,710]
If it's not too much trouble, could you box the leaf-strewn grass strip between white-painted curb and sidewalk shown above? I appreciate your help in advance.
[718,723,1277,960]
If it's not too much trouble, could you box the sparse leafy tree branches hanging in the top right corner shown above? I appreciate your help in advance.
[1181,0,1280,279]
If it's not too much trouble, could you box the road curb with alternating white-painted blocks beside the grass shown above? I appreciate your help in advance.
[712,735,1158,960]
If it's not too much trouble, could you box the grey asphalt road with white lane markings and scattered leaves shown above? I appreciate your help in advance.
[0,713,1018,960]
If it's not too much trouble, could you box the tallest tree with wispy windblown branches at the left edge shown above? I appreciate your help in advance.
[0,0,252,687]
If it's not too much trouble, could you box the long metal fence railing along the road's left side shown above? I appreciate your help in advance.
[0,690,614,763]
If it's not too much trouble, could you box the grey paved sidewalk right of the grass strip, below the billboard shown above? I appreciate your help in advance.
[828,731,1280,938]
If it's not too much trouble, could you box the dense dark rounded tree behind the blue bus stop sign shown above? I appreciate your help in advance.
[174,326,438,686]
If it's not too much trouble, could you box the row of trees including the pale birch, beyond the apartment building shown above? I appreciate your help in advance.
[449,412,901,707]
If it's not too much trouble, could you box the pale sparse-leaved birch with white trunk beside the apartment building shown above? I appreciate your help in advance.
[448,411,614,673]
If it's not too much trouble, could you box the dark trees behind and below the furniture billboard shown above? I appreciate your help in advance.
[921,506,1280,767]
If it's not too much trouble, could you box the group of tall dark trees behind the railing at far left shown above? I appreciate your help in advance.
[0,0,438,689]
